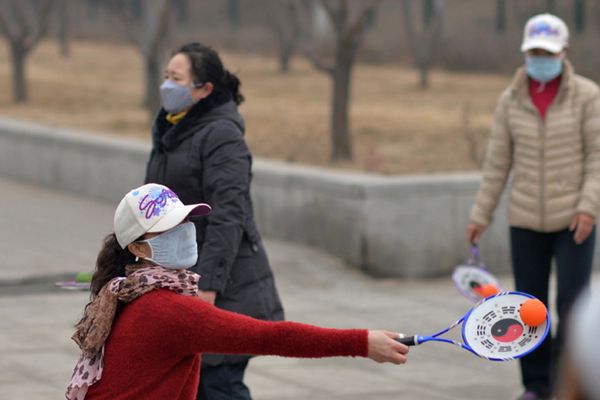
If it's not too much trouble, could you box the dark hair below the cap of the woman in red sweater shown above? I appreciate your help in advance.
[90,233,135,299]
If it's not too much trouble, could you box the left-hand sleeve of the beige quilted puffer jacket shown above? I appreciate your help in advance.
[470,92,512,226]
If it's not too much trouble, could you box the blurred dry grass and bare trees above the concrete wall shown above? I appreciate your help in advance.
[0,0,600,174]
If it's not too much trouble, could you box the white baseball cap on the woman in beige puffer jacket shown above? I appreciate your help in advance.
[521,13,569,53]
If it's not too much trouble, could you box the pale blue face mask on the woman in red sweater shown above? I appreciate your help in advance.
[141,222,198,269]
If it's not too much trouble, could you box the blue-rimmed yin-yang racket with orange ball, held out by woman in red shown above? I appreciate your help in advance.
[397,292,550,361]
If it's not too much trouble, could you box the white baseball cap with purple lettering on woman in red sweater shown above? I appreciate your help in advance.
[114,183,211,249]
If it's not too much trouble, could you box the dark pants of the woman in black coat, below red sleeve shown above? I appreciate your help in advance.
[197,361,252,400]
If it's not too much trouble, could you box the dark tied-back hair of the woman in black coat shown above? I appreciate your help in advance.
[172,42,244,105]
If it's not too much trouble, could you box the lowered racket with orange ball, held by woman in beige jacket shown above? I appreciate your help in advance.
[452,244,501,301]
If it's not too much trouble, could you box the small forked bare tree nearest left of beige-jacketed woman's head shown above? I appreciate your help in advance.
[402,0,445,90]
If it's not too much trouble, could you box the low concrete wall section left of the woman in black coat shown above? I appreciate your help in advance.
[0,119,150,201]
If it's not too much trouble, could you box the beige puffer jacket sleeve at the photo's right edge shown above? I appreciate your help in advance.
[576,88,600,217]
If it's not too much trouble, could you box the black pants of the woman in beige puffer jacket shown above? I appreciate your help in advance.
[510,227,596,393]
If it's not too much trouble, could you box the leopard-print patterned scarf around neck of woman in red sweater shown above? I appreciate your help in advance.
[66,264,200,400]
